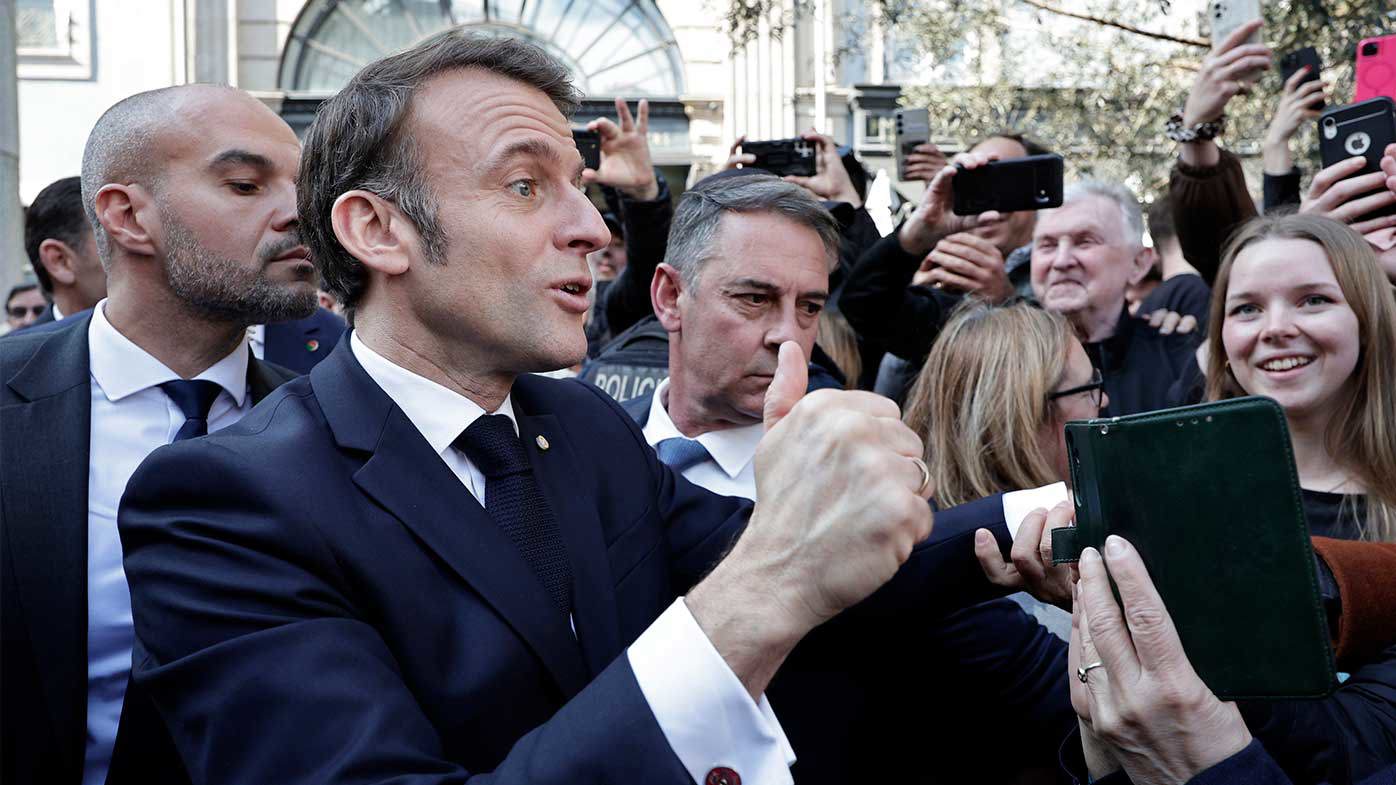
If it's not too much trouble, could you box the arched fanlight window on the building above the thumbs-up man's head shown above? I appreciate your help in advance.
[281,0,684,98]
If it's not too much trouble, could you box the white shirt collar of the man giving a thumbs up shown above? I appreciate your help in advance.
[349,330,519,455]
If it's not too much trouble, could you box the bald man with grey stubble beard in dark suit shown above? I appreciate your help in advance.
[0,87,315,785]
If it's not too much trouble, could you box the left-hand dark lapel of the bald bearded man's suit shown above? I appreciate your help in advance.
[0,318,92,760]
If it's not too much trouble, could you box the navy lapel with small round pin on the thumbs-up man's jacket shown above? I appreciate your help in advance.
[514,410,620,675]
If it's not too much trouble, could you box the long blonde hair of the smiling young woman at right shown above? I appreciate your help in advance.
[1206,215,1396,542]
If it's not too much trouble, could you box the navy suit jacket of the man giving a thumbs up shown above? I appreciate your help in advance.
[111,342,1038,785]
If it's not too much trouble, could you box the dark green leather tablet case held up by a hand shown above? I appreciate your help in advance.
[1053,397,1337,700]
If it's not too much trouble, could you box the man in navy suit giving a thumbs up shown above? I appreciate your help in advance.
[121,31,1027,784]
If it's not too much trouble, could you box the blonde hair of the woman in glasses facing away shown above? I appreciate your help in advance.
[902,299,1072,506]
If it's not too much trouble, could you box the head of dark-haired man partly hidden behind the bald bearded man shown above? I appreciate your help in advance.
[24,177,106,324]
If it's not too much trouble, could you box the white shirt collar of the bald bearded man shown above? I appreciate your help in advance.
[88,294,251,406]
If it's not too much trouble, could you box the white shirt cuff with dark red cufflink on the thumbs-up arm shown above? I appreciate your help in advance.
[627,598,794,785]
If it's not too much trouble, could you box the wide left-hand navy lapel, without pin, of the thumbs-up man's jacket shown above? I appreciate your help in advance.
[310,337,589,697]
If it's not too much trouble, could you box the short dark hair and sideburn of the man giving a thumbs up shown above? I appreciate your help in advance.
[297,28,581,306]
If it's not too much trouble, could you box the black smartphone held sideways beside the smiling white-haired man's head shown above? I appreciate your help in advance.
[953,154,1065,215]
